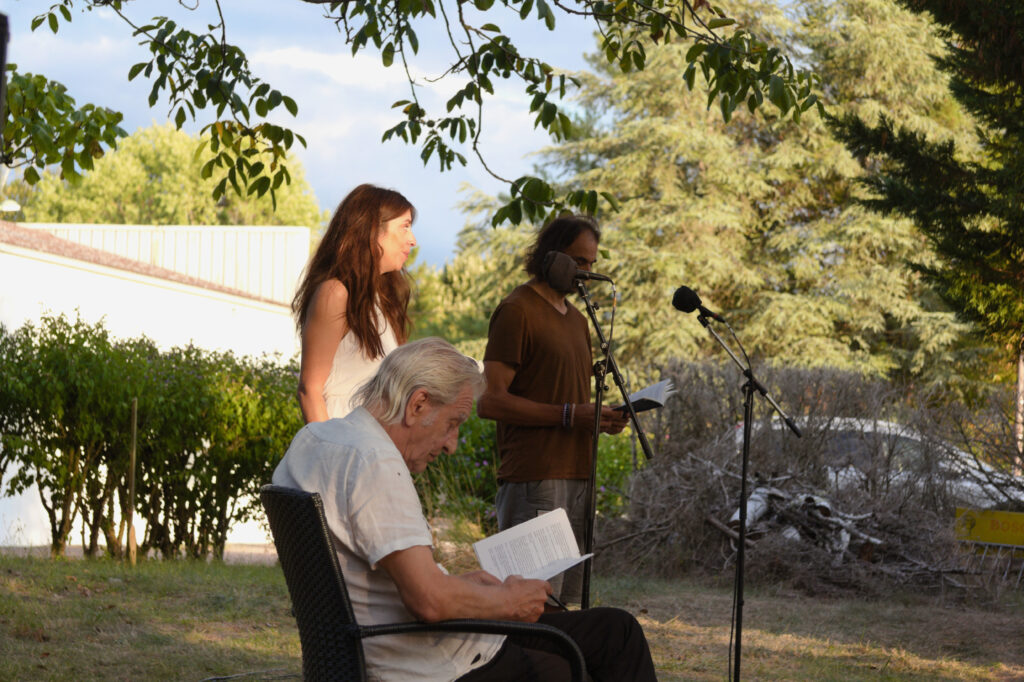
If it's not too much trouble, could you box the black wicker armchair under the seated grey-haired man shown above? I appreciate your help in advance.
[260,485,585,681]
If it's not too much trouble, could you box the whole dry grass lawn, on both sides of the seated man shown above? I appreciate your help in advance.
[0,556,1024,681]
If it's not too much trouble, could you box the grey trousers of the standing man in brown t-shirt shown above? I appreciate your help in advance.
[495,478,587,603]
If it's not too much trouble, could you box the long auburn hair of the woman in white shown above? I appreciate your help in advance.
[292,184,416,357]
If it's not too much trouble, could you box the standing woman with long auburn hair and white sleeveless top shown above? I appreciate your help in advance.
[292,184,416,423]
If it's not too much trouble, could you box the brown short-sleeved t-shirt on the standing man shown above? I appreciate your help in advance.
[483,285,593,482]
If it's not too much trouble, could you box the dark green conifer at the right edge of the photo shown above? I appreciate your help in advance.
[834,0,1024,453]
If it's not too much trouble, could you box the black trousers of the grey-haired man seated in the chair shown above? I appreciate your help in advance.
[458,607,657,682]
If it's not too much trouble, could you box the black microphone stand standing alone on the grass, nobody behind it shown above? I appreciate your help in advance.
[697,309,801,682]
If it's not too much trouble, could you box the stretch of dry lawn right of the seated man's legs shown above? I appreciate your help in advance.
[595,580,1024,681]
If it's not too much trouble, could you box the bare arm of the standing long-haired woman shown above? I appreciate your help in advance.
[298,279,348,424]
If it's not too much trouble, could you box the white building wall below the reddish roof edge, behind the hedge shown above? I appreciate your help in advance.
[0,238,299,546]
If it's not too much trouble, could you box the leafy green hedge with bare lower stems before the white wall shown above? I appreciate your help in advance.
[0,314,301,557]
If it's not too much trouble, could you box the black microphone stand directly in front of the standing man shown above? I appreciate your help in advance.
[575,280,652,608]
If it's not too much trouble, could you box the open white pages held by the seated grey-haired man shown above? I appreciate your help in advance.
[473,507,594,581]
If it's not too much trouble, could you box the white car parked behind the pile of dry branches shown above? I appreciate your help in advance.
[733,417,1024,508]
